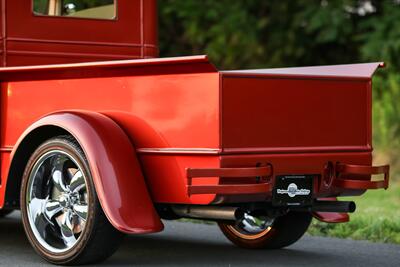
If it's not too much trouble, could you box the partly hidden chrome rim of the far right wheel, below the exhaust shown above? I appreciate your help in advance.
[227,213,275,240]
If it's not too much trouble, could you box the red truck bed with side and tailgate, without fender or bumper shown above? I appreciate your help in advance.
[0,56,381,207]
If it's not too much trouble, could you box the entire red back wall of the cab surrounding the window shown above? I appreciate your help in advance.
[2,0,158,66]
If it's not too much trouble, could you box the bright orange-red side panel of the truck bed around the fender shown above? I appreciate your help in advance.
[0,59,219,203]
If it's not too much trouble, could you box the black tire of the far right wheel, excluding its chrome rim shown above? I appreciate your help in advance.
[218,212,312,249]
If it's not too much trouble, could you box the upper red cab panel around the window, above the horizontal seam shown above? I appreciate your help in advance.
[6,0,141,44]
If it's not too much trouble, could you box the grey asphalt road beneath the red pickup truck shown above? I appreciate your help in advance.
[0,213,400,267]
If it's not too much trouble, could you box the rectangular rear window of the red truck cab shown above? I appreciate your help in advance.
[33,0,117,19]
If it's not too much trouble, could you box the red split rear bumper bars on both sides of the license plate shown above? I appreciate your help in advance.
[186,163,389,197]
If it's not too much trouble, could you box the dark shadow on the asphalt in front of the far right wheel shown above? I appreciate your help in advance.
[104,236,334,266]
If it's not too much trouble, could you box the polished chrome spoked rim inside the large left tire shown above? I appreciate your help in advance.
[25,150,89,253]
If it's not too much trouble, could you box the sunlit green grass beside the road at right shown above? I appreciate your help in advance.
[308,182,400,244]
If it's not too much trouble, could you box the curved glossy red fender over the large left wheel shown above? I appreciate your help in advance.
[14,111,163,234]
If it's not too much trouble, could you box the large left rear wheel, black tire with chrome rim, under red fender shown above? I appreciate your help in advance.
[21,136,124,265]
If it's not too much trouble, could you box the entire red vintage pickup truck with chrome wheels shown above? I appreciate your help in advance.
[0,0,389,265]
